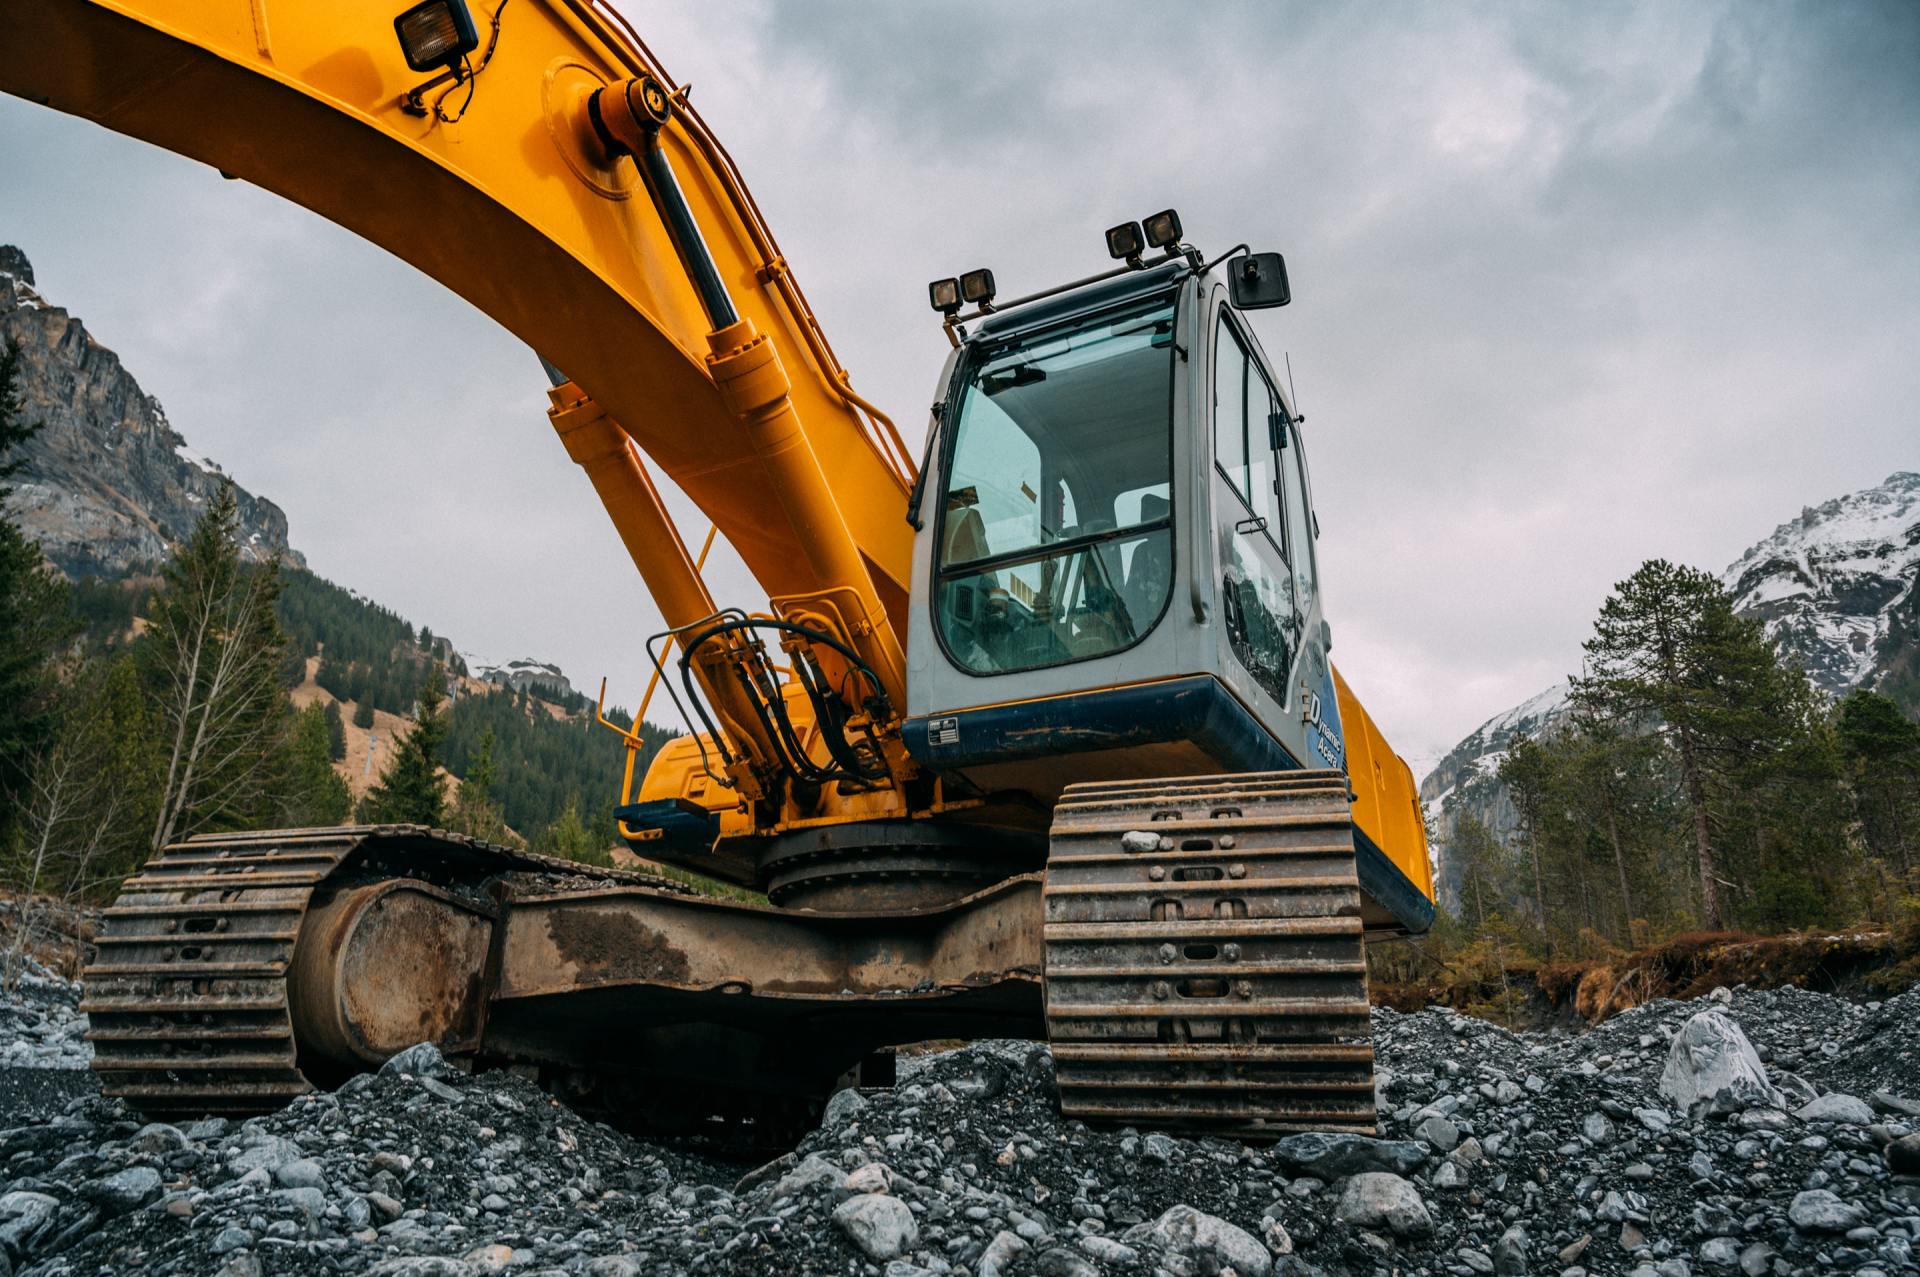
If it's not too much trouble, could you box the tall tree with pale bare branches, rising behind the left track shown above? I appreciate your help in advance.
[142,482,286,851]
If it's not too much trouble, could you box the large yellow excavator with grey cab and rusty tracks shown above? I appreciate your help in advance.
[0,0,1432,1143]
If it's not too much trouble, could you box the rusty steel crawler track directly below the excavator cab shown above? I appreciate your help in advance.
[1044,772,1375,1139]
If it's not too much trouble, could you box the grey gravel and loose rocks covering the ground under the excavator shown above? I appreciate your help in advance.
[0,956,1920,1277]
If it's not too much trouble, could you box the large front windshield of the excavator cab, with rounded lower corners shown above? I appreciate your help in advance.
[935,294,1173,674]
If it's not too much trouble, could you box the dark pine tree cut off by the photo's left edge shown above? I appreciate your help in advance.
[0,340,81,849]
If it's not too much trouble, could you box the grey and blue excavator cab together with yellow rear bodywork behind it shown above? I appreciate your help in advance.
[904,250,1432,931]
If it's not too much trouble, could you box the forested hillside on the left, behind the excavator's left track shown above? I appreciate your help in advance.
[0,334,670,921]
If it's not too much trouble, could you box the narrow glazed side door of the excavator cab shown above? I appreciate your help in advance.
[1212,307,1308,710]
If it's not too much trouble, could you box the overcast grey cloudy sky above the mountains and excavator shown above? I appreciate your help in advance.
[0,0,1920,766]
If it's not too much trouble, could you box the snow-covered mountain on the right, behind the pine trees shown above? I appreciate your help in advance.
[1421,470,1920,908]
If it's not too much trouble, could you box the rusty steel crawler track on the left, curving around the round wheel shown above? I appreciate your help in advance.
[81,826,682,1118]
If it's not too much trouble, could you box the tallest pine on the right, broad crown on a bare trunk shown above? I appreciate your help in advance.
[1572,559,1786,928]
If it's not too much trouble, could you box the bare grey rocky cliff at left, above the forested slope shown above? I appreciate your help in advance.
[0,244,305,576]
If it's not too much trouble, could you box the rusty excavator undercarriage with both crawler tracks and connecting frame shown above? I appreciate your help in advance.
[84,772,1373,1144]
